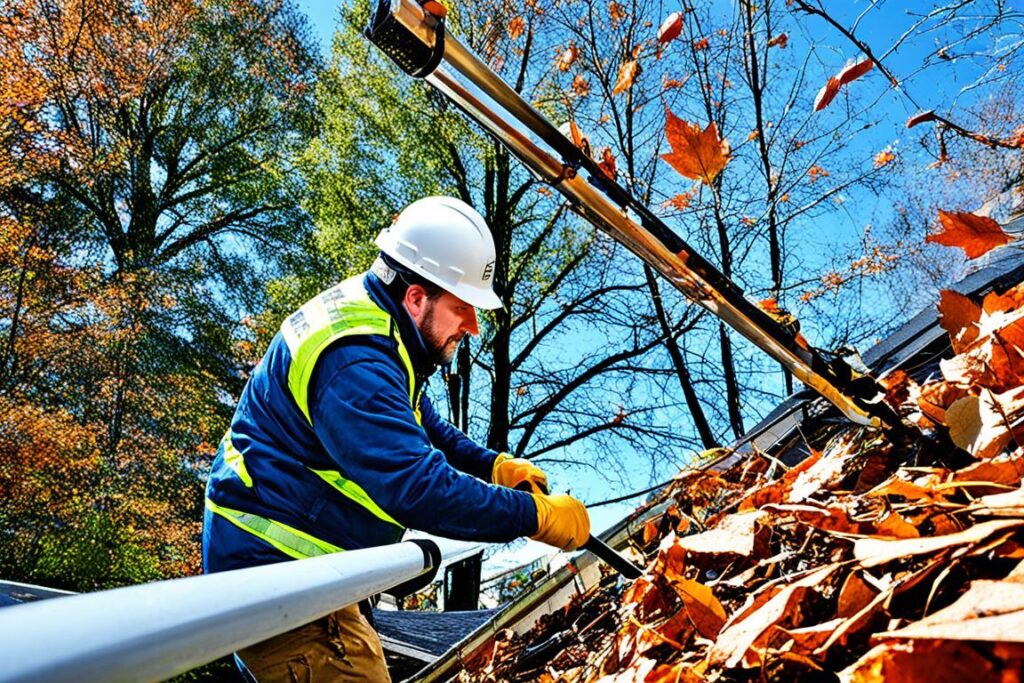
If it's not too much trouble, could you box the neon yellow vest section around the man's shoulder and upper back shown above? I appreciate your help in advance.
[281,275,421,424]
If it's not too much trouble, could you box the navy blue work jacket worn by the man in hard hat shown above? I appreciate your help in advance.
[203,273,537,572]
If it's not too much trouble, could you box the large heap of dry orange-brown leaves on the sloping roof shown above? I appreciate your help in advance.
[462,278,1024,683]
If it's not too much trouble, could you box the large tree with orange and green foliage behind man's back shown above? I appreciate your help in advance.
[0,0,316,588]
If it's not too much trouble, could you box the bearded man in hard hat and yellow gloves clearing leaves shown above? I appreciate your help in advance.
[203,197,590,682]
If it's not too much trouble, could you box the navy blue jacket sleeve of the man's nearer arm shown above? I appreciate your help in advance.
[310,343,537,543]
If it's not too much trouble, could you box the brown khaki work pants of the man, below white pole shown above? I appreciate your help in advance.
[237,605,391,683]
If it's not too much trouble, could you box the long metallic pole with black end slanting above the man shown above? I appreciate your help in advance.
[365,0,906,432]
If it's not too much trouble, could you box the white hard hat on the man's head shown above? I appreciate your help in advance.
[374,197,502,309]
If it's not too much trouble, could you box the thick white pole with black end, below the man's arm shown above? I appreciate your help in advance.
[0,540,440,683]
